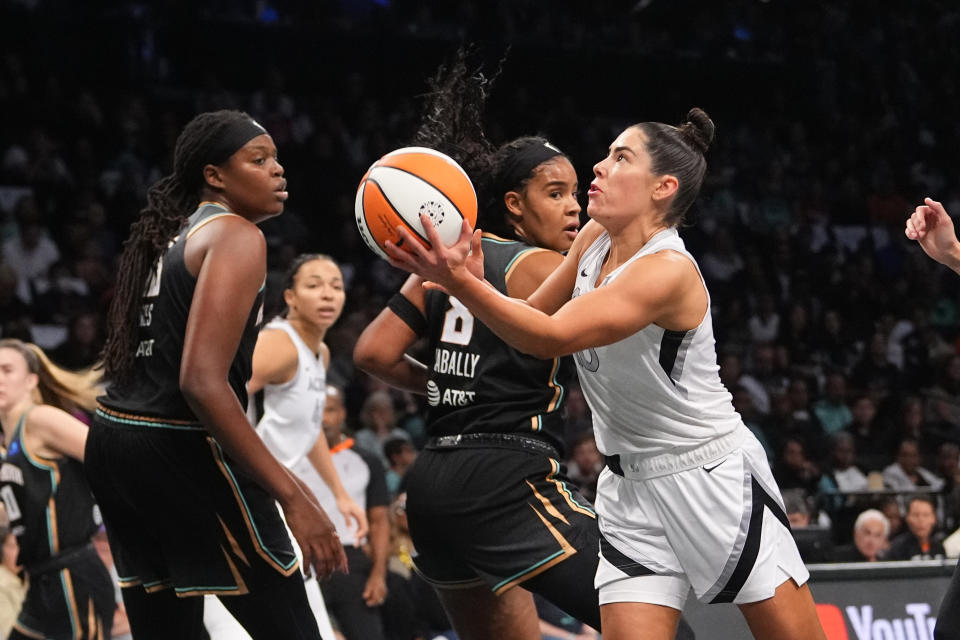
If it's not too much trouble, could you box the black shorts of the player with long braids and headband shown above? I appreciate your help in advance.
[84,412,299,597]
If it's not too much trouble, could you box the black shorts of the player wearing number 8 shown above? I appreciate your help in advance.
[406,448,599,594]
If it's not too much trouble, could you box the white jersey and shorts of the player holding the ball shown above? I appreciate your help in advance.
[574,229,809,609]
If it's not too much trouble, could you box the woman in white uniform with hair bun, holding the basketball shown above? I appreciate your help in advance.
[388,109,824,640]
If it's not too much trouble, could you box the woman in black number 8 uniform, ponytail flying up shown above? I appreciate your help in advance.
[354,55,689,640]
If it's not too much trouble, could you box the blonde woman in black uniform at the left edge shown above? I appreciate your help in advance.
[0,339,116,640]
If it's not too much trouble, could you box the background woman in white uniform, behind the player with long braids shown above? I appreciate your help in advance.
[207,254,366,640]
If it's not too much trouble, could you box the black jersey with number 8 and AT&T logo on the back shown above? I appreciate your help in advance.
[426,234,574,452]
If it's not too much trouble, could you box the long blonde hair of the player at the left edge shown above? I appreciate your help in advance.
[0,338,103,413]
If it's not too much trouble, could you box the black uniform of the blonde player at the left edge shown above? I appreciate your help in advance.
[0,410,116,640]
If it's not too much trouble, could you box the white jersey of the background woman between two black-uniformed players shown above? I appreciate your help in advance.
[257,318,327,469]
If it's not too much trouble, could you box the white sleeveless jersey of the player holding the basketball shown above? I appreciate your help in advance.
[573,229,743,476]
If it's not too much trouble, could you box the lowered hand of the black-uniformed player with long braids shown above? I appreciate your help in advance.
[282,491,347,580]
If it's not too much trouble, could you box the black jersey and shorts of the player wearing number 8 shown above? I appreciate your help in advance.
[406,234,600,628]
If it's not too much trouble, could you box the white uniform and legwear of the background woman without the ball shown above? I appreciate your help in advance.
[203,318,334,640]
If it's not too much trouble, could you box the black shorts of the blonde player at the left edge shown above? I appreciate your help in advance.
[13,545,117,640]
